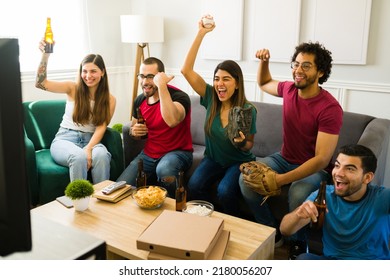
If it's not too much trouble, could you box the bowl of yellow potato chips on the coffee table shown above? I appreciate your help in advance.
[132,186,168,209]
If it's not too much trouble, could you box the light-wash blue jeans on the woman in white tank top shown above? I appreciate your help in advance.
[50,127,111,184]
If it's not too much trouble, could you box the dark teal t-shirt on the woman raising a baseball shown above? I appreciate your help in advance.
[200,85,257,167]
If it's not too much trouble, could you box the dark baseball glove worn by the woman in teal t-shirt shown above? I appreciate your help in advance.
[226,106,252,147]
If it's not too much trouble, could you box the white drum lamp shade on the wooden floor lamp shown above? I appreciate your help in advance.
[120,15,164,43]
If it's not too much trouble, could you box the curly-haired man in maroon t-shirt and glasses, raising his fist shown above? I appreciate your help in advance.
[240,42,343,259]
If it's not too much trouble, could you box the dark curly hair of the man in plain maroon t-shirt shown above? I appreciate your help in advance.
[291,42,333,84]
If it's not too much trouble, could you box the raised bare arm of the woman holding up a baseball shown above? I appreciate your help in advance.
[181,17,215,97]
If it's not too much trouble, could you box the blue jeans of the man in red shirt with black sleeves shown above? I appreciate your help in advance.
[117,150,193,198]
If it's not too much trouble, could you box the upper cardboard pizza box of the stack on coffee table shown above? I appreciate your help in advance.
[137,210,224,260]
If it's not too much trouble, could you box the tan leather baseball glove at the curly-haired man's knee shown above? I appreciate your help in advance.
[240,161,281,204]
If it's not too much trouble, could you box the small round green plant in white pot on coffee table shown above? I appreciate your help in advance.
[65,179,95,211]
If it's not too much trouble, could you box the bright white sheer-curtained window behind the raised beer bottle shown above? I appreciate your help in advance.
[0,0,89,72]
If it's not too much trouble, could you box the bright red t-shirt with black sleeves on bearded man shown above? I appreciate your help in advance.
[133,86,193,159]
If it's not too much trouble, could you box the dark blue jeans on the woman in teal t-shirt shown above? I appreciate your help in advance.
[188,157,241,216]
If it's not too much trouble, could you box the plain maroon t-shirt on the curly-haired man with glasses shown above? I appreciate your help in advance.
[278,82,343,170]
